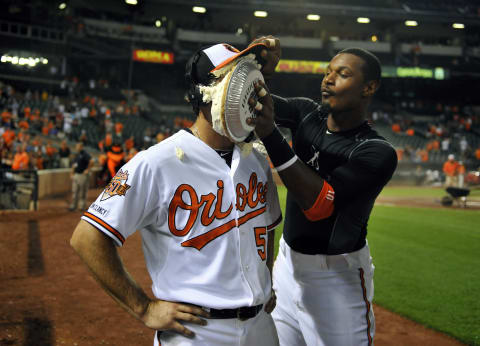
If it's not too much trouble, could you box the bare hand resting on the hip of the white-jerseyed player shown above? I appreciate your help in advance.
[142,300,209,337]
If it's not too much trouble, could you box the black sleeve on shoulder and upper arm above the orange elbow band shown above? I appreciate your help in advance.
[327,141,397,206]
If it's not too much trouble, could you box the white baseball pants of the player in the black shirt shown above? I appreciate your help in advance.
[272,237,375,346]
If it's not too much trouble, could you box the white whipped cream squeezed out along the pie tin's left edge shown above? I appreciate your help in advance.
[199,54,261,136]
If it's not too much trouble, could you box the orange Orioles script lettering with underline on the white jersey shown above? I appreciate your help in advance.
[168,173,267,248]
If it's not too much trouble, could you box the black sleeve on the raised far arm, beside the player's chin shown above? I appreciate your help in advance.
[272,95,320,132]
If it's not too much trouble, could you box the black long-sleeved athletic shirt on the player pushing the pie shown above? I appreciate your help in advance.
[273,96,397,255]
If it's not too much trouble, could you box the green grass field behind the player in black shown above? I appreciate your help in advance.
[275,187,480,345]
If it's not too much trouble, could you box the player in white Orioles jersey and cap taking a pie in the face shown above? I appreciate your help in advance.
[70,45,281,346]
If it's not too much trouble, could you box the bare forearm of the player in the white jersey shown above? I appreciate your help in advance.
[70,220,150,319]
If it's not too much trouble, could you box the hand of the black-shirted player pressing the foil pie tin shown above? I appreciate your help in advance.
[247,81,275,139]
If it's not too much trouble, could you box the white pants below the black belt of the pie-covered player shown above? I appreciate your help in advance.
[154,309,279,346]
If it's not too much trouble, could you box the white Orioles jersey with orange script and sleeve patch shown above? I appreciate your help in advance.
[82,130,282,309]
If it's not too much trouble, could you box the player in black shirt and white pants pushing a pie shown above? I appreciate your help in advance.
[249,38,397,346]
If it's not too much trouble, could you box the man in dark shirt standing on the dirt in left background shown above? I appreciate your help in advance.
[69,142,93,211]
